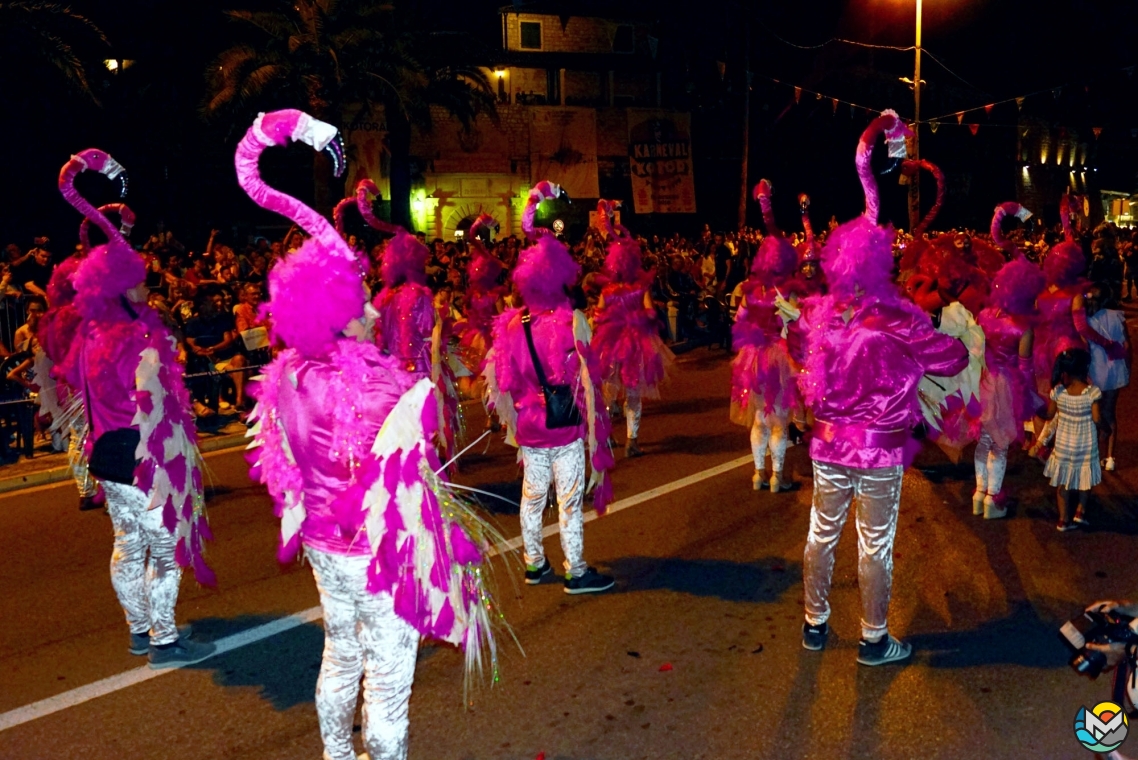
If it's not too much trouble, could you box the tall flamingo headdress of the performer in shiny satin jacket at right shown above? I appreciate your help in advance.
[822,110,913,298]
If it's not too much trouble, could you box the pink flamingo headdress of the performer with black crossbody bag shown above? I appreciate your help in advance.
[511,180,580,311]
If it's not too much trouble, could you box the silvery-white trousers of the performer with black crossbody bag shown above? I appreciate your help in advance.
[521,439,587,577]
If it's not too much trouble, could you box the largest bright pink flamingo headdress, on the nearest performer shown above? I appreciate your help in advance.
[236,109,368,356]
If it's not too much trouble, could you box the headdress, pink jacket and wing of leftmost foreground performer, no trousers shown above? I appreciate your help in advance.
[59,148,216,586]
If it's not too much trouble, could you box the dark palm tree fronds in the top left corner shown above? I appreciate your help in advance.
[0,0,108,102]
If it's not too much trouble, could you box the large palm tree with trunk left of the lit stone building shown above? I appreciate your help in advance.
[201,0,496,225]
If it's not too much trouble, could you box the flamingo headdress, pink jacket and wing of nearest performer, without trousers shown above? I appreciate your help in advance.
[236,110,497,670]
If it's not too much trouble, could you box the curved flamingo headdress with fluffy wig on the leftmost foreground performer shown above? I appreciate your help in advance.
[59,148,146,320]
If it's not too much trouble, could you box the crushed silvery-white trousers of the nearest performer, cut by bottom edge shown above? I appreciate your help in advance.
[305,547,419,760]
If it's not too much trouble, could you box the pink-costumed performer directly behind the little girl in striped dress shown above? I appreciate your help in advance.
[1030,196,1125,459]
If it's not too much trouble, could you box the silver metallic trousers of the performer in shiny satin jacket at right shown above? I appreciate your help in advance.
[802,462,905,641]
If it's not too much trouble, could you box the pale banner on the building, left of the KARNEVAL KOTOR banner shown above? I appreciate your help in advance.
[529,107,601,199]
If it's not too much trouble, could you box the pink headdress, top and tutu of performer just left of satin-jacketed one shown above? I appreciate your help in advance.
[731,180,798,428]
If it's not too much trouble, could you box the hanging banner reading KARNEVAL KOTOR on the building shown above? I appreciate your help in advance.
[628,108,695,214]
